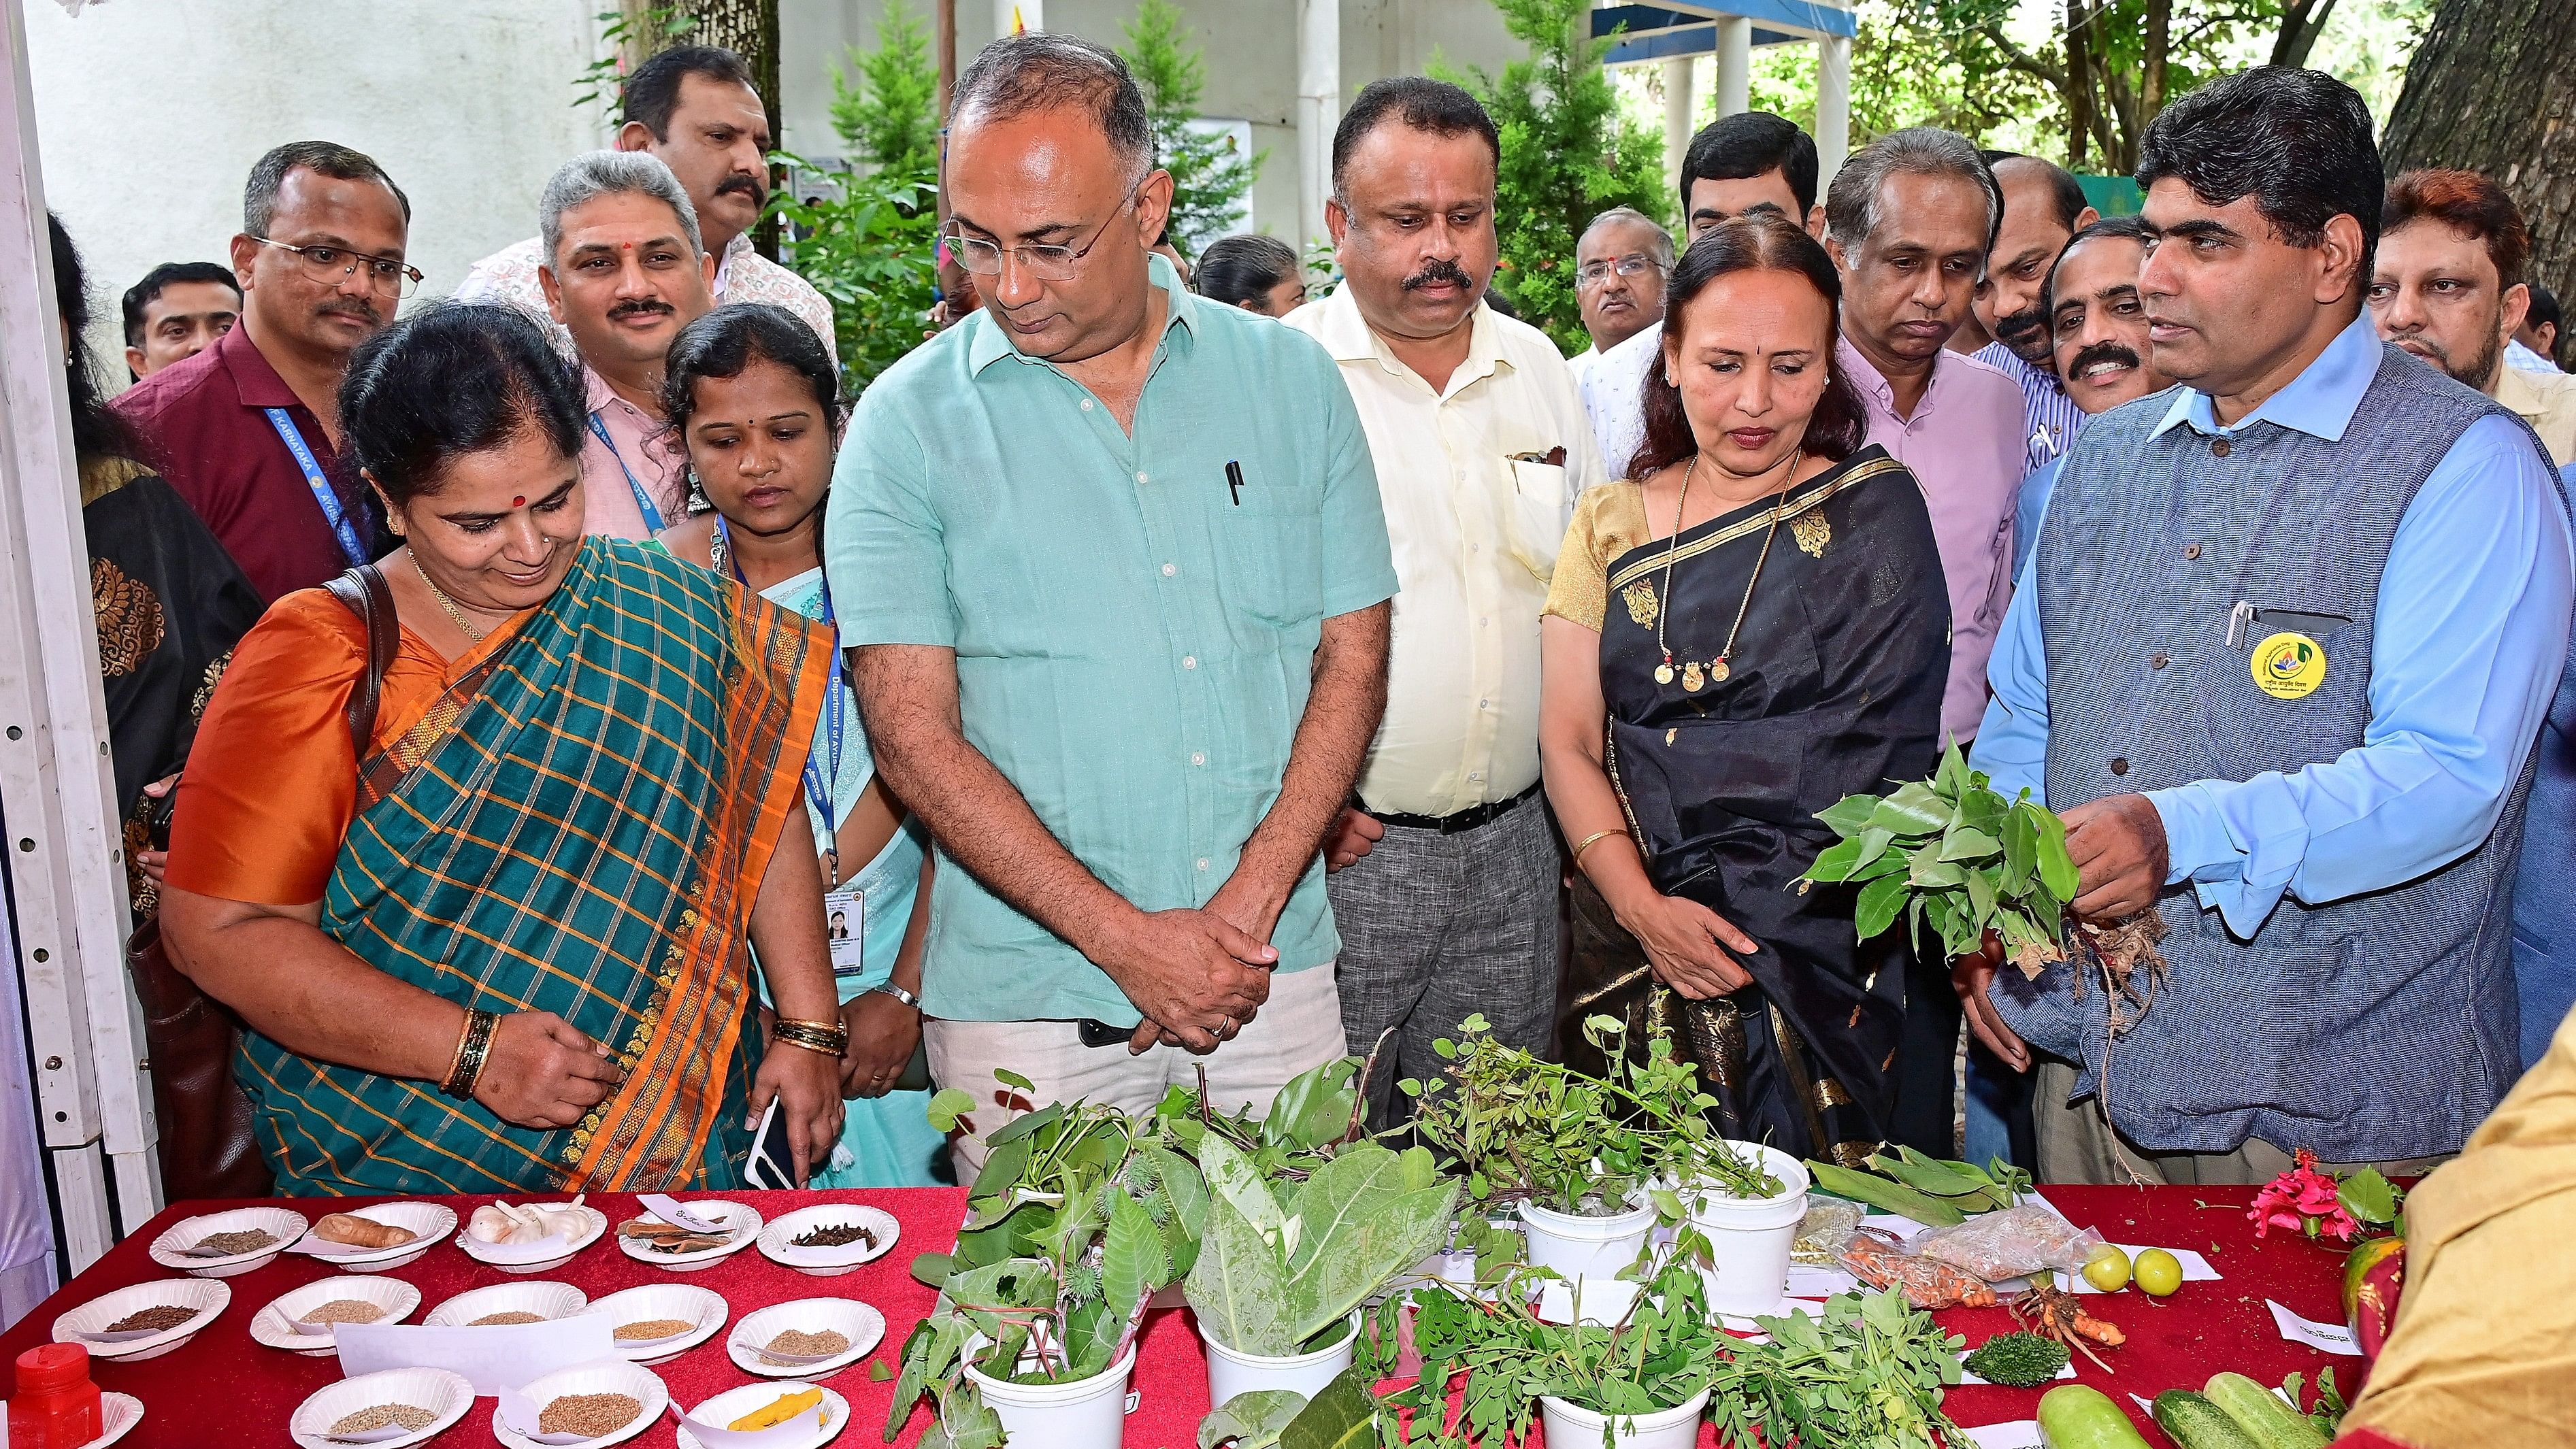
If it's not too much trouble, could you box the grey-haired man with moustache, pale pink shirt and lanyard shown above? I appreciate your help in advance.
[538,152,716,540]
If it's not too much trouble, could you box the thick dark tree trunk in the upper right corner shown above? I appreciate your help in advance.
[2380,0,2576,299]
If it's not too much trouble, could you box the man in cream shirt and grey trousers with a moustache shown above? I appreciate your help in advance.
[1288,77,1602,1127]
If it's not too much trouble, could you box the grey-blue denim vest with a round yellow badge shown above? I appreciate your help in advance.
[2004,348,2532,1161]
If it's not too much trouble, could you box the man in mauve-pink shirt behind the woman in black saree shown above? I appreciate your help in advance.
[1823,126,2028,1158]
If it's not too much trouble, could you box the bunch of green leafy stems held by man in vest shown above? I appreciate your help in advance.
[1803,742,2077,976]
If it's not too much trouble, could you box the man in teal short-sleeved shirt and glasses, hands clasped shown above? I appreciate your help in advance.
[825,33,1396,1169]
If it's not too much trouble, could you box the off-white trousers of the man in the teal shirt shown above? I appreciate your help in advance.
[922,963,1342,1184]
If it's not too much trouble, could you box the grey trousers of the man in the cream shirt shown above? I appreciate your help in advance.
[1324,795,1564,1130]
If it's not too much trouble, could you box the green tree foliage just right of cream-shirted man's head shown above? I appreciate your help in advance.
[1432,0,1672,352]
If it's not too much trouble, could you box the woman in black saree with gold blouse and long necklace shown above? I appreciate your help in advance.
[1540,216,1950,1163]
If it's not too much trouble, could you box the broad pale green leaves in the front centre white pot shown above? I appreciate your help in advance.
[1187,1135,1458,1356]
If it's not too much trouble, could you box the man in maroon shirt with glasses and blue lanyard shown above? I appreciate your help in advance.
[116,141,420,602]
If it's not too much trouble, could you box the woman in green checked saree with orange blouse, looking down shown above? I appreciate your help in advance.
[163,306,840,1194]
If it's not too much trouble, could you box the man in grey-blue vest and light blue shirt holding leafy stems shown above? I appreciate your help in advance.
[1958,67,2571,1184]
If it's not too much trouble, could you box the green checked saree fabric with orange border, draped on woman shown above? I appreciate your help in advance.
[240,538,829,1194]
